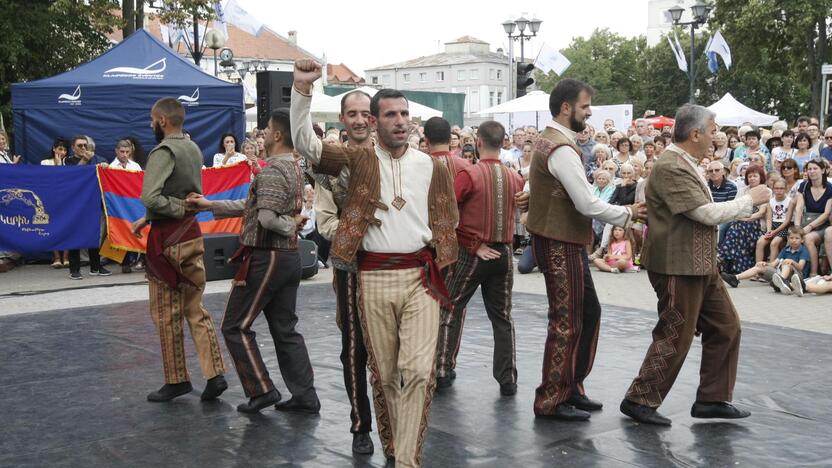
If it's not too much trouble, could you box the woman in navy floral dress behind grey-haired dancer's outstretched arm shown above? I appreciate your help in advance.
[717,164,766,274]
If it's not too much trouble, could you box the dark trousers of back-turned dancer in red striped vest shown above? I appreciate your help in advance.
[436,244,517,384]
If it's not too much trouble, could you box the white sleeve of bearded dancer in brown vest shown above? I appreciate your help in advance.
[548,146,630,226]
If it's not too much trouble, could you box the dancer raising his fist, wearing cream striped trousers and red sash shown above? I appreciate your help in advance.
[291,60,458,466]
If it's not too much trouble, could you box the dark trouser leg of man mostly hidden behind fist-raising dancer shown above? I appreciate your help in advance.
[332,268,373,433]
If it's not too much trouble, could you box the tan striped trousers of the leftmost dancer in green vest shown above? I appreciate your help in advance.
[147,237,225,384]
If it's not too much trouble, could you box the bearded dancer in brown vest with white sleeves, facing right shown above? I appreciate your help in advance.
[526,79,646,421]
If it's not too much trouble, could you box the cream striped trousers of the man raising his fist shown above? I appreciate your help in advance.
[358,268,439,467]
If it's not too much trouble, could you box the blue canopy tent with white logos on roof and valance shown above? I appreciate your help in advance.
[12,30,245,165]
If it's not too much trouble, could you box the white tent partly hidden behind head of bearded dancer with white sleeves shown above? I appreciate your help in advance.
[477,91,633,130]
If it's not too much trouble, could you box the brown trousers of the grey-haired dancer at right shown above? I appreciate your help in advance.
[626,272,741,408]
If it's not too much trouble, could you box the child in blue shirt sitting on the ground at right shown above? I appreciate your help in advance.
[721,226,809,296]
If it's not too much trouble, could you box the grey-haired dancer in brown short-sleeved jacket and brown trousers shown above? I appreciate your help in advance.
[621,104,770,426]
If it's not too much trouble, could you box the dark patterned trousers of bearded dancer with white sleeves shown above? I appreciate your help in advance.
[532,236,601,415]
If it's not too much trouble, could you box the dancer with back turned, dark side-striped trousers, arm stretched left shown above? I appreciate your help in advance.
[189,109,321,414]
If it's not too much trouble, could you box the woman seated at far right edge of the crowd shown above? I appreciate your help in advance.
[794,160,832,276]
